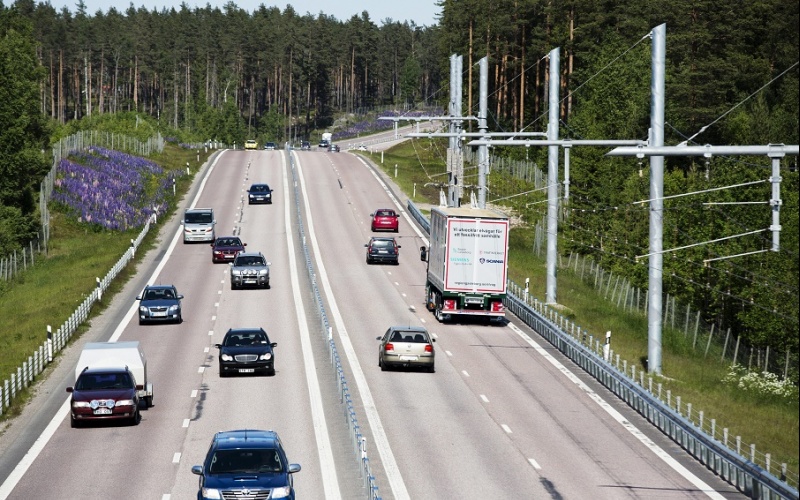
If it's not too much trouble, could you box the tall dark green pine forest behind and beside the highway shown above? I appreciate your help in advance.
[0,0,800,356]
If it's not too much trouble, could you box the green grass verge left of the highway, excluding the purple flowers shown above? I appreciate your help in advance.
[0,144,211,420]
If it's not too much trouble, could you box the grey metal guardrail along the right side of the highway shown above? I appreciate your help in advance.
[408,200,798,500]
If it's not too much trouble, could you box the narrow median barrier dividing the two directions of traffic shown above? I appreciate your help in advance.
[286,145,381,500]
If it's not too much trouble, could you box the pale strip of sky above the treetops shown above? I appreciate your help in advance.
[41,0,440,26]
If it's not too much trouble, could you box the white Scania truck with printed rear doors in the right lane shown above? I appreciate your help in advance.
[420,207,509,322]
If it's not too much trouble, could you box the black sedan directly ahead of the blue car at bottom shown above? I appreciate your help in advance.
[215,328,278,377]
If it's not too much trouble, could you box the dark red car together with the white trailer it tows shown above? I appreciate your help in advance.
[67,341,153,427]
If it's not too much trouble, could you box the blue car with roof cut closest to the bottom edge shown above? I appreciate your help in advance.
[192,429,300,500]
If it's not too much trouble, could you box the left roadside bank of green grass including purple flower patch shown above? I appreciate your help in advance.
[0,137,211,421]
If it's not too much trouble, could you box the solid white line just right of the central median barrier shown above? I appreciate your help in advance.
[297,150,416,500]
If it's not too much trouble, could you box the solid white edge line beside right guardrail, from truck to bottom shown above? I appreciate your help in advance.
[508,323,725,500]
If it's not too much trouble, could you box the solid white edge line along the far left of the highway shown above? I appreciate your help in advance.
[0,151,225,500]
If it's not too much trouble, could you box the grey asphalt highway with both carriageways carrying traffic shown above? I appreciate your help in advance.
[0,146,742,500]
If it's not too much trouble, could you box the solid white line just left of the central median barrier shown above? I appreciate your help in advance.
[288,153,342,500]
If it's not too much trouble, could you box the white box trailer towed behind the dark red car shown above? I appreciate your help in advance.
[75,341,153,408]
